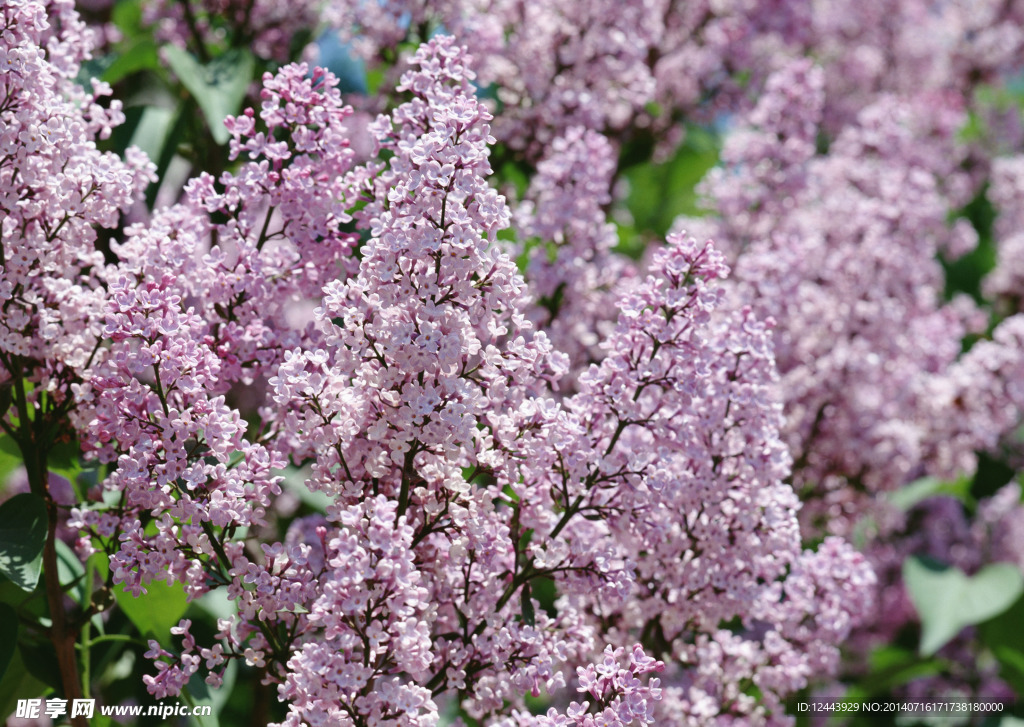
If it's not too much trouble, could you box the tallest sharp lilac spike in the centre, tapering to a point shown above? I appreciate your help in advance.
[270,39,589,724]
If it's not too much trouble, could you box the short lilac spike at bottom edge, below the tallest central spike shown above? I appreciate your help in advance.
[281,496,437,725]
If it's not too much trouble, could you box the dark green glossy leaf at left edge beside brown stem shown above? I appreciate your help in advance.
[0,493,46,591]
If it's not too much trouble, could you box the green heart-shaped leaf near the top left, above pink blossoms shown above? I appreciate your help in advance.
[163,45,256,144]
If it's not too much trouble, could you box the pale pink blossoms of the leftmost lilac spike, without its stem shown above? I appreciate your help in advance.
[0,2,153,405]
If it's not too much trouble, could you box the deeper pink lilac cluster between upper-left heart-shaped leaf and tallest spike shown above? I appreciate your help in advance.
[69,65,364,444]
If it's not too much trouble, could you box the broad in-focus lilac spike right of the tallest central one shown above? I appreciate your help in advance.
[535,237,872,724]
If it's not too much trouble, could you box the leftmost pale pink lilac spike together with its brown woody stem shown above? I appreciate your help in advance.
[0,0,153,716]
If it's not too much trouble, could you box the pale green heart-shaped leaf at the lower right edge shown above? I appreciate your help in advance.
[903,556,1024,656]
